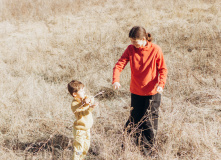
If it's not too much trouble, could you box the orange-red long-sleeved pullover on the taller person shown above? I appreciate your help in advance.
[112,42,167,96]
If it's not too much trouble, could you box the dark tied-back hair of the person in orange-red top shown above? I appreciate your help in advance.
[129,26,152,42]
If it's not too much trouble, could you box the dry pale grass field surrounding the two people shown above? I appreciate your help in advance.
[0,0,221,160]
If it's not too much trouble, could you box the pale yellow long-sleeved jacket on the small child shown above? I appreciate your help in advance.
[71,97,93,130]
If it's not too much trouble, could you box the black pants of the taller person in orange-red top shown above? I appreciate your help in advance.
[124,94,161,148]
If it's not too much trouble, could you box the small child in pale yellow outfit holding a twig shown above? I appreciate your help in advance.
[68,80,97,160]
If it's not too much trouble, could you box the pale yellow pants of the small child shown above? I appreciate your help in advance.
[73,129,90,160]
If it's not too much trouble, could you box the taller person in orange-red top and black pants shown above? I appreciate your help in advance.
[112,26,167,151]
